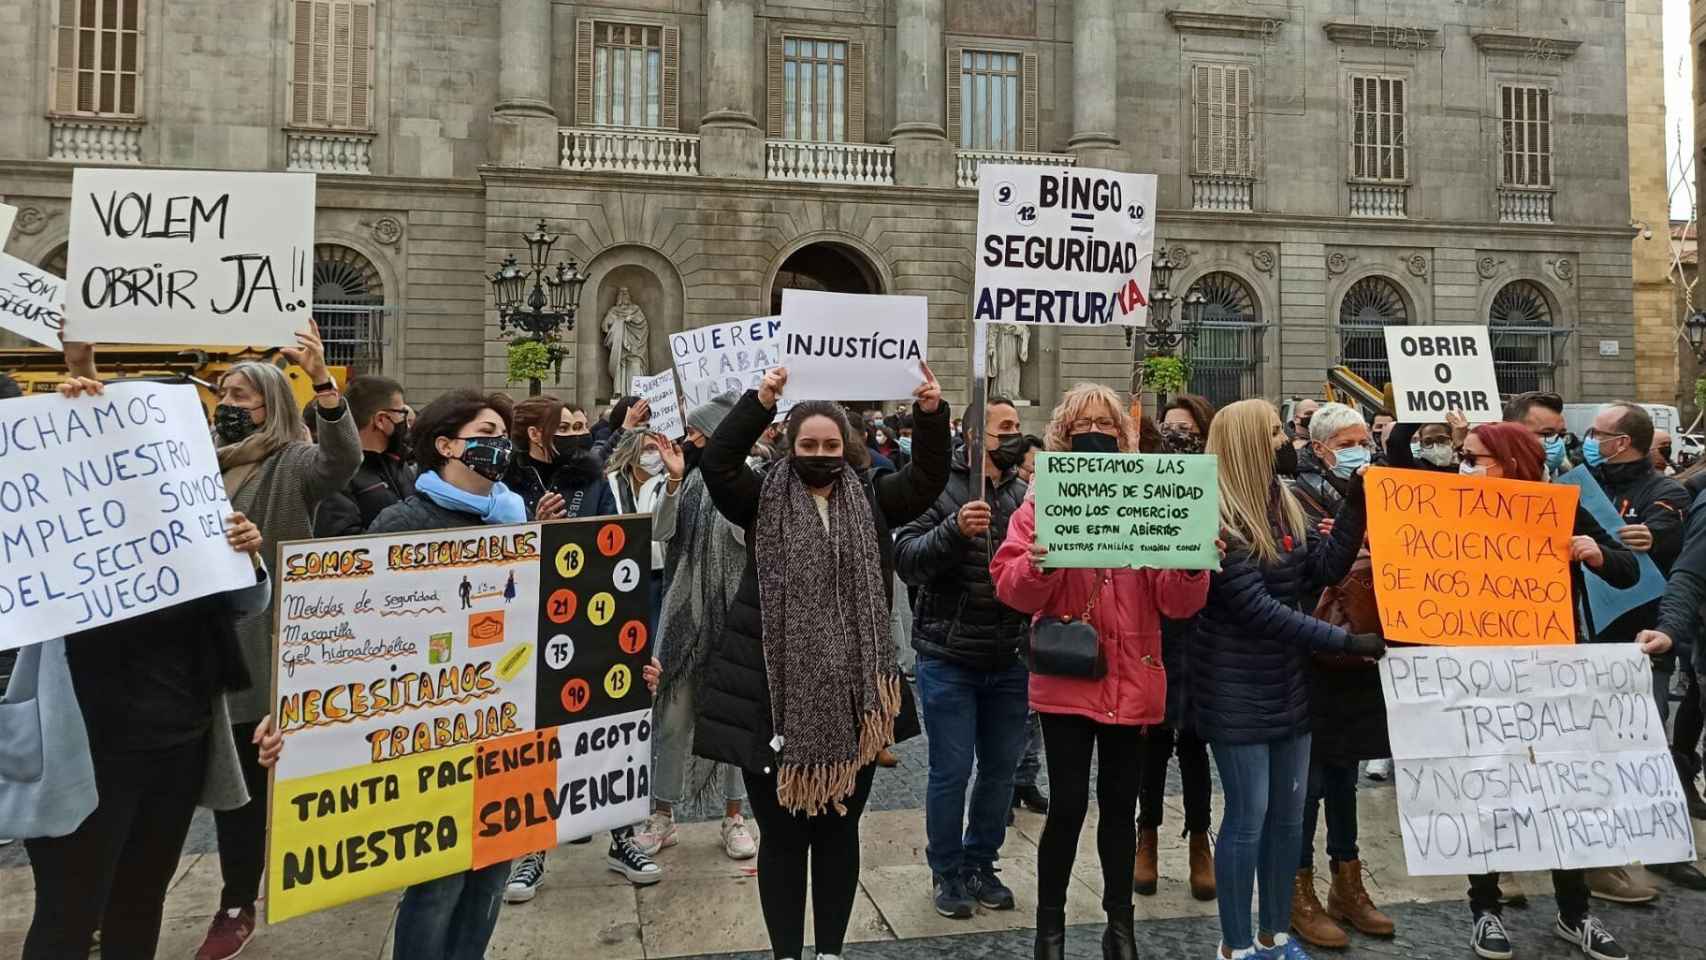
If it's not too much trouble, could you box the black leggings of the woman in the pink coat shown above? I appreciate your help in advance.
[1037,713,1143,911]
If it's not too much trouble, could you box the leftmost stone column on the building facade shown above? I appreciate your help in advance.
[491,0,558,167]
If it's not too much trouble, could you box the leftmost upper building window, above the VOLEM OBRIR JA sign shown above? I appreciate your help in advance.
[53,0,142,118]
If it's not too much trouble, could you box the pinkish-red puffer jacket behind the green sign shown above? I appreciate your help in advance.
[989,500,1208,726]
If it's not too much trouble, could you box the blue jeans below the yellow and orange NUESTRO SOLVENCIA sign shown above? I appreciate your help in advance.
[394,859,510,960]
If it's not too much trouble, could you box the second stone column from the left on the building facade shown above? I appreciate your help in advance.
[699,0,764,177]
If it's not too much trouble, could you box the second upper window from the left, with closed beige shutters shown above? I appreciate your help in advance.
[290,0,374,130]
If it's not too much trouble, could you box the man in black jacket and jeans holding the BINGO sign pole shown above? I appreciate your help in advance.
[894,399,1030,917]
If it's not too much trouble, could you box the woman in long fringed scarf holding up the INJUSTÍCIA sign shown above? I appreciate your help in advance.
[694,367,949,960]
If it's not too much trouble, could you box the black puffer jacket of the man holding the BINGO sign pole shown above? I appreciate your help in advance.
[894,452,1030,670]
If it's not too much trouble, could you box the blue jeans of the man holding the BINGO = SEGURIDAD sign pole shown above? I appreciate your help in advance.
[916,656,1030,875]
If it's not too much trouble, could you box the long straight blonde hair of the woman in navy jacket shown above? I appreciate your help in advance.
[1208,399,1309,566]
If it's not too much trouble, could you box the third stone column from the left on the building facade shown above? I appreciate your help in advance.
[889,0,954,186]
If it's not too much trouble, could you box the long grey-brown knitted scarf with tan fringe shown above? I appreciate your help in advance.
[751,462,901,817]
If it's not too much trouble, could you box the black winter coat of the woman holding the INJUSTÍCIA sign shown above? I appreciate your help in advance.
[693,390,949,774]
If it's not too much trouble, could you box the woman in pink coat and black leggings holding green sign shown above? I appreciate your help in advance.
[989,384,1208,960]
